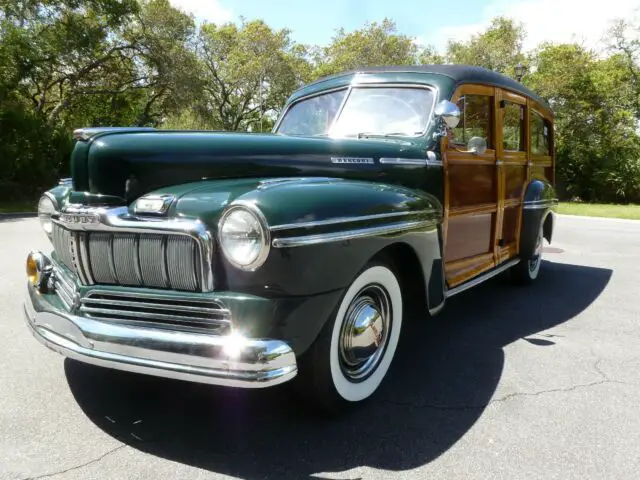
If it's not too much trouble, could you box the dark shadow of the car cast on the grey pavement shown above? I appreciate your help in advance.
[65,262,612,478]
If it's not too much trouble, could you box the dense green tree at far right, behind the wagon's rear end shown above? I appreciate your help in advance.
[527,44,640,201]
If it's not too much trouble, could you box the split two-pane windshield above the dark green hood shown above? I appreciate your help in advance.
[277,87,434,137]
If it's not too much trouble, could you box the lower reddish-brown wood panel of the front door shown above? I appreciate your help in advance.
[445,213,495,262]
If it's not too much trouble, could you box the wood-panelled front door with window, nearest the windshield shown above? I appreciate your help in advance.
[441,85,500,287]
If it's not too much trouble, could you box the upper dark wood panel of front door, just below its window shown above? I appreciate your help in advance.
[448,163,497,208]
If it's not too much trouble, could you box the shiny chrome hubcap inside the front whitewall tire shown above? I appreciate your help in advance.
[339,285,391,382]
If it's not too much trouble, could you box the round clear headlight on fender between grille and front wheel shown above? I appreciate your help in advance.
[218,205,269,271]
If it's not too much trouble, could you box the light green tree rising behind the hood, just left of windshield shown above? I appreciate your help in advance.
[197,20,310,130]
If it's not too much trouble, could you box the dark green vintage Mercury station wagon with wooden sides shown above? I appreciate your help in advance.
[25,65,557,409]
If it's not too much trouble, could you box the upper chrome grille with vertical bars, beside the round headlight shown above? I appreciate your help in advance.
[53,224,202,291]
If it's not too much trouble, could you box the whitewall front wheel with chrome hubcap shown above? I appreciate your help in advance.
[298,263,403,411]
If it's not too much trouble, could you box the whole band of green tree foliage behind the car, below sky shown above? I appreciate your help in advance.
[0,0,640,201]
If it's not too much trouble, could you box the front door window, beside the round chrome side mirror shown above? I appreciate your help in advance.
[450,95,494,148]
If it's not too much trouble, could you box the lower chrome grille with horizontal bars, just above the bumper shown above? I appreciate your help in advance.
[80,290,231,335]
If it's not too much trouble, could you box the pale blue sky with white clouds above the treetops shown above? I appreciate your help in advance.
[170,0,640,52]
